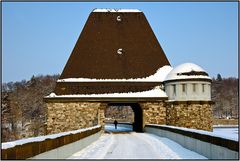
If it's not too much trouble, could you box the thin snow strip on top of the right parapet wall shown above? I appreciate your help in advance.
[148,124,238,141]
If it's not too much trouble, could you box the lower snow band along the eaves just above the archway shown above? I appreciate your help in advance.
[46,86,167,98]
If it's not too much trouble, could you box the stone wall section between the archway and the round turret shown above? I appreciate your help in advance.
[140,101,166,126]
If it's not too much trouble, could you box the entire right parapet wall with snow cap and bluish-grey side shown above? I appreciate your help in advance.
[144,124,239,159]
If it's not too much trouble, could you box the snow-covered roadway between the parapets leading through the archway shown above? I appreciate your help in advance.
[69,125,207,159]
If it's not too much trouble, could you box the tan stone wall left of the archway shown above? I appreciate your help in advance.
[47,102,101,134]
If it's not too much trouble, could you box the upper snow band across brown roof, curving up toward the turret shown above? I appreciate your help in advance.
[57,65,172,82]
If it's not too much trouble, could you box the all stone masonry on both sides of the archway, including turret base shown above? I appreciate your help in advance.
[47,101,213,134]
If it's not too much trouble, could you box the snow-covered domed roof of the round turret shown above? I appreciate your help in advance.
[164,63,211,81]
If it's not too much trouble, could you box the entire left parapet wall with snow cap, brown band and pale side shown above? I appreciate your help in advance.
[1,126,102,160]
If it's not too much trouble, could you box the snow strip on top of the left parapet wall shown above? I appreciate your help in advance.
[2,125,100,149]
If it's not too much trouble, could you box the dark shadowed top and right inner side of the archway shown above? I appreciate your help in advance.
[108,103,143,132]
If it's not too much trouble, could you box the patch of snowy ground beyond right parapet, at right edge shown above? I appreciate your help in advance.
[213,127,239,140]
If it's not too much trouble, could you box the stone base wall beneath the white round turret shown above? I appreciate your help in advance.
[166,102,213,131]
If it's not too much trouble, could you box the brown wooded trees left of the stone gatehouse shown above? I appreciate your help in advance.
[1,75,59,142]
